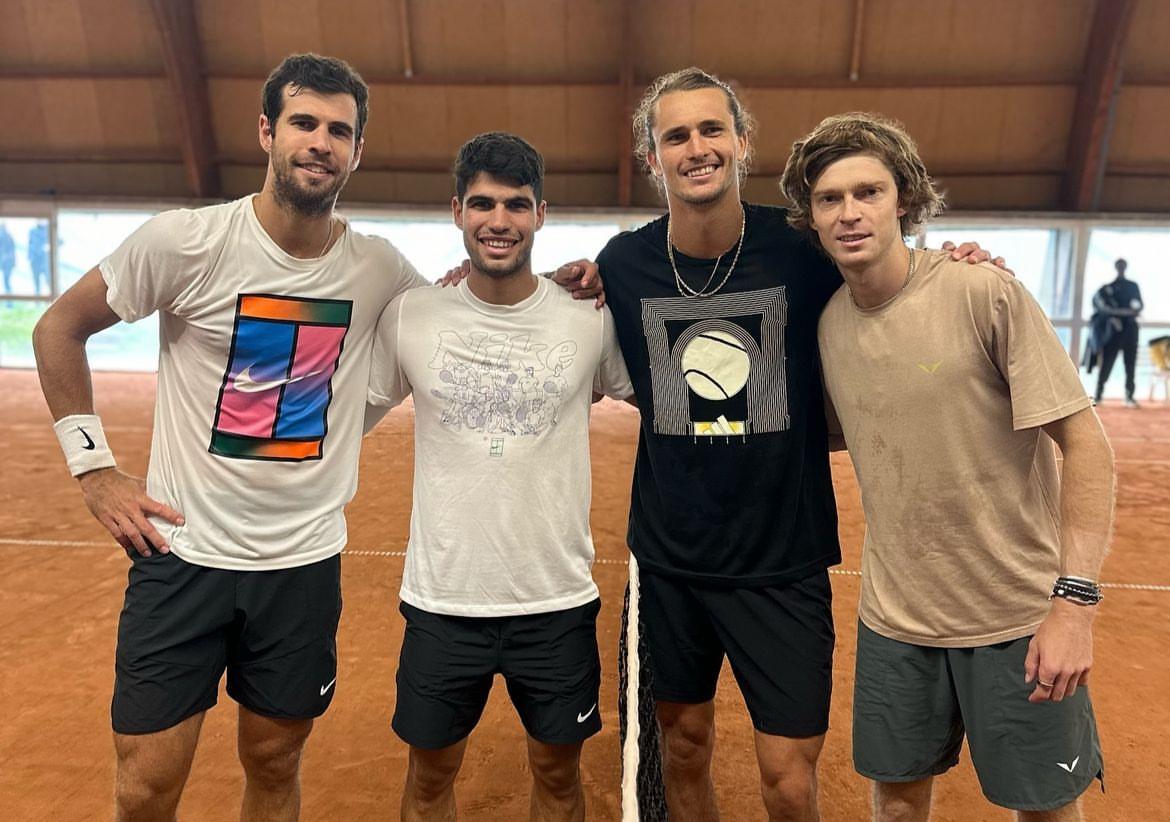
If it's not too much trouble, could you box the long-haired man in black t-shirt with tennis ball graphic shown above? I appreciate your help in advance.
[598,68,1001,820]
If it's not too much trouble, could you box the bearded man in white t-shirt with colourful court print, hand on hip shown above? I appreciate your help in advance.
[34,55,599,820]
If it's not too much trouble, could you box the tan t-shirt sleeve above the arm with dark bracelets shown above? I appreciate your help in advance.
[990,274,1090,430]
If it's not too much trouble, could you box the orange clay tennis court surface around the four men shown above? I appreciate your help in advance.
[0,371,1170,822]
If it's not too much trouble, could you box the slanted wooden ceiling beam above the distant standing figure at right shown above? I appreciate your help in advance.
[1060,0,1136,212]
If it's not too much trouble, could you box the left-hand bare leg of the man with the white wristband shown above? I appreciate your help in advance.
[113,713,204,822]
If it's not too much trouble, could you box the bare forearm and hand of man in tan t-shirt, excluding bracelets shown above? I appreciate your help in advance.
[1025,408,1115,702]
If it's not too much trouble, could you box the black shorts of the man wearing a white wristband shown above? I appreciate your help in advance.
[110,553,342,733]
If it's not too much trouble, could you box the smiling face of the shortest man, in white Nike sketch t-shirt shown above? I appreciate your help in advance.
[450,172,545,279]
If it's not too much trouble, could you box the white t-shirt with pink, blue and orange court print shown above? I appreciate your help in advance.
[101,196,427,571]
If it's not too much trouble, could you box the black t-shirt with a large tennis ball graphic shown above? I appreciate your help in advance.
[597,203,841,586]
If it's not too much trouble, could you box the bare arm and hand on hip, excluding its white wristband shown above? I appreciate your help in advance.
[33,268,183,557]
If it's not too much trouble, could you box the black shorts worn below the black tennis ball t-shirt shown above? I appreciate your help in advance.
[639,571,834,737]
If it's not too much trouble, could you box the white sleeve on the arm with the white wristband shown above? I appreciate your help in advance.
[98,209,208,323]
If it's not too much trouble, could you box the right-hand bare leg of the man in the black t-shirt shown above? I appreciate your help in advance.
[756,731,825,822]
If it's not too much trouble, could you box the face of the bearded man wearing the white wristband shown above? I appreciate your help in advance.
[260,84,362,216]
